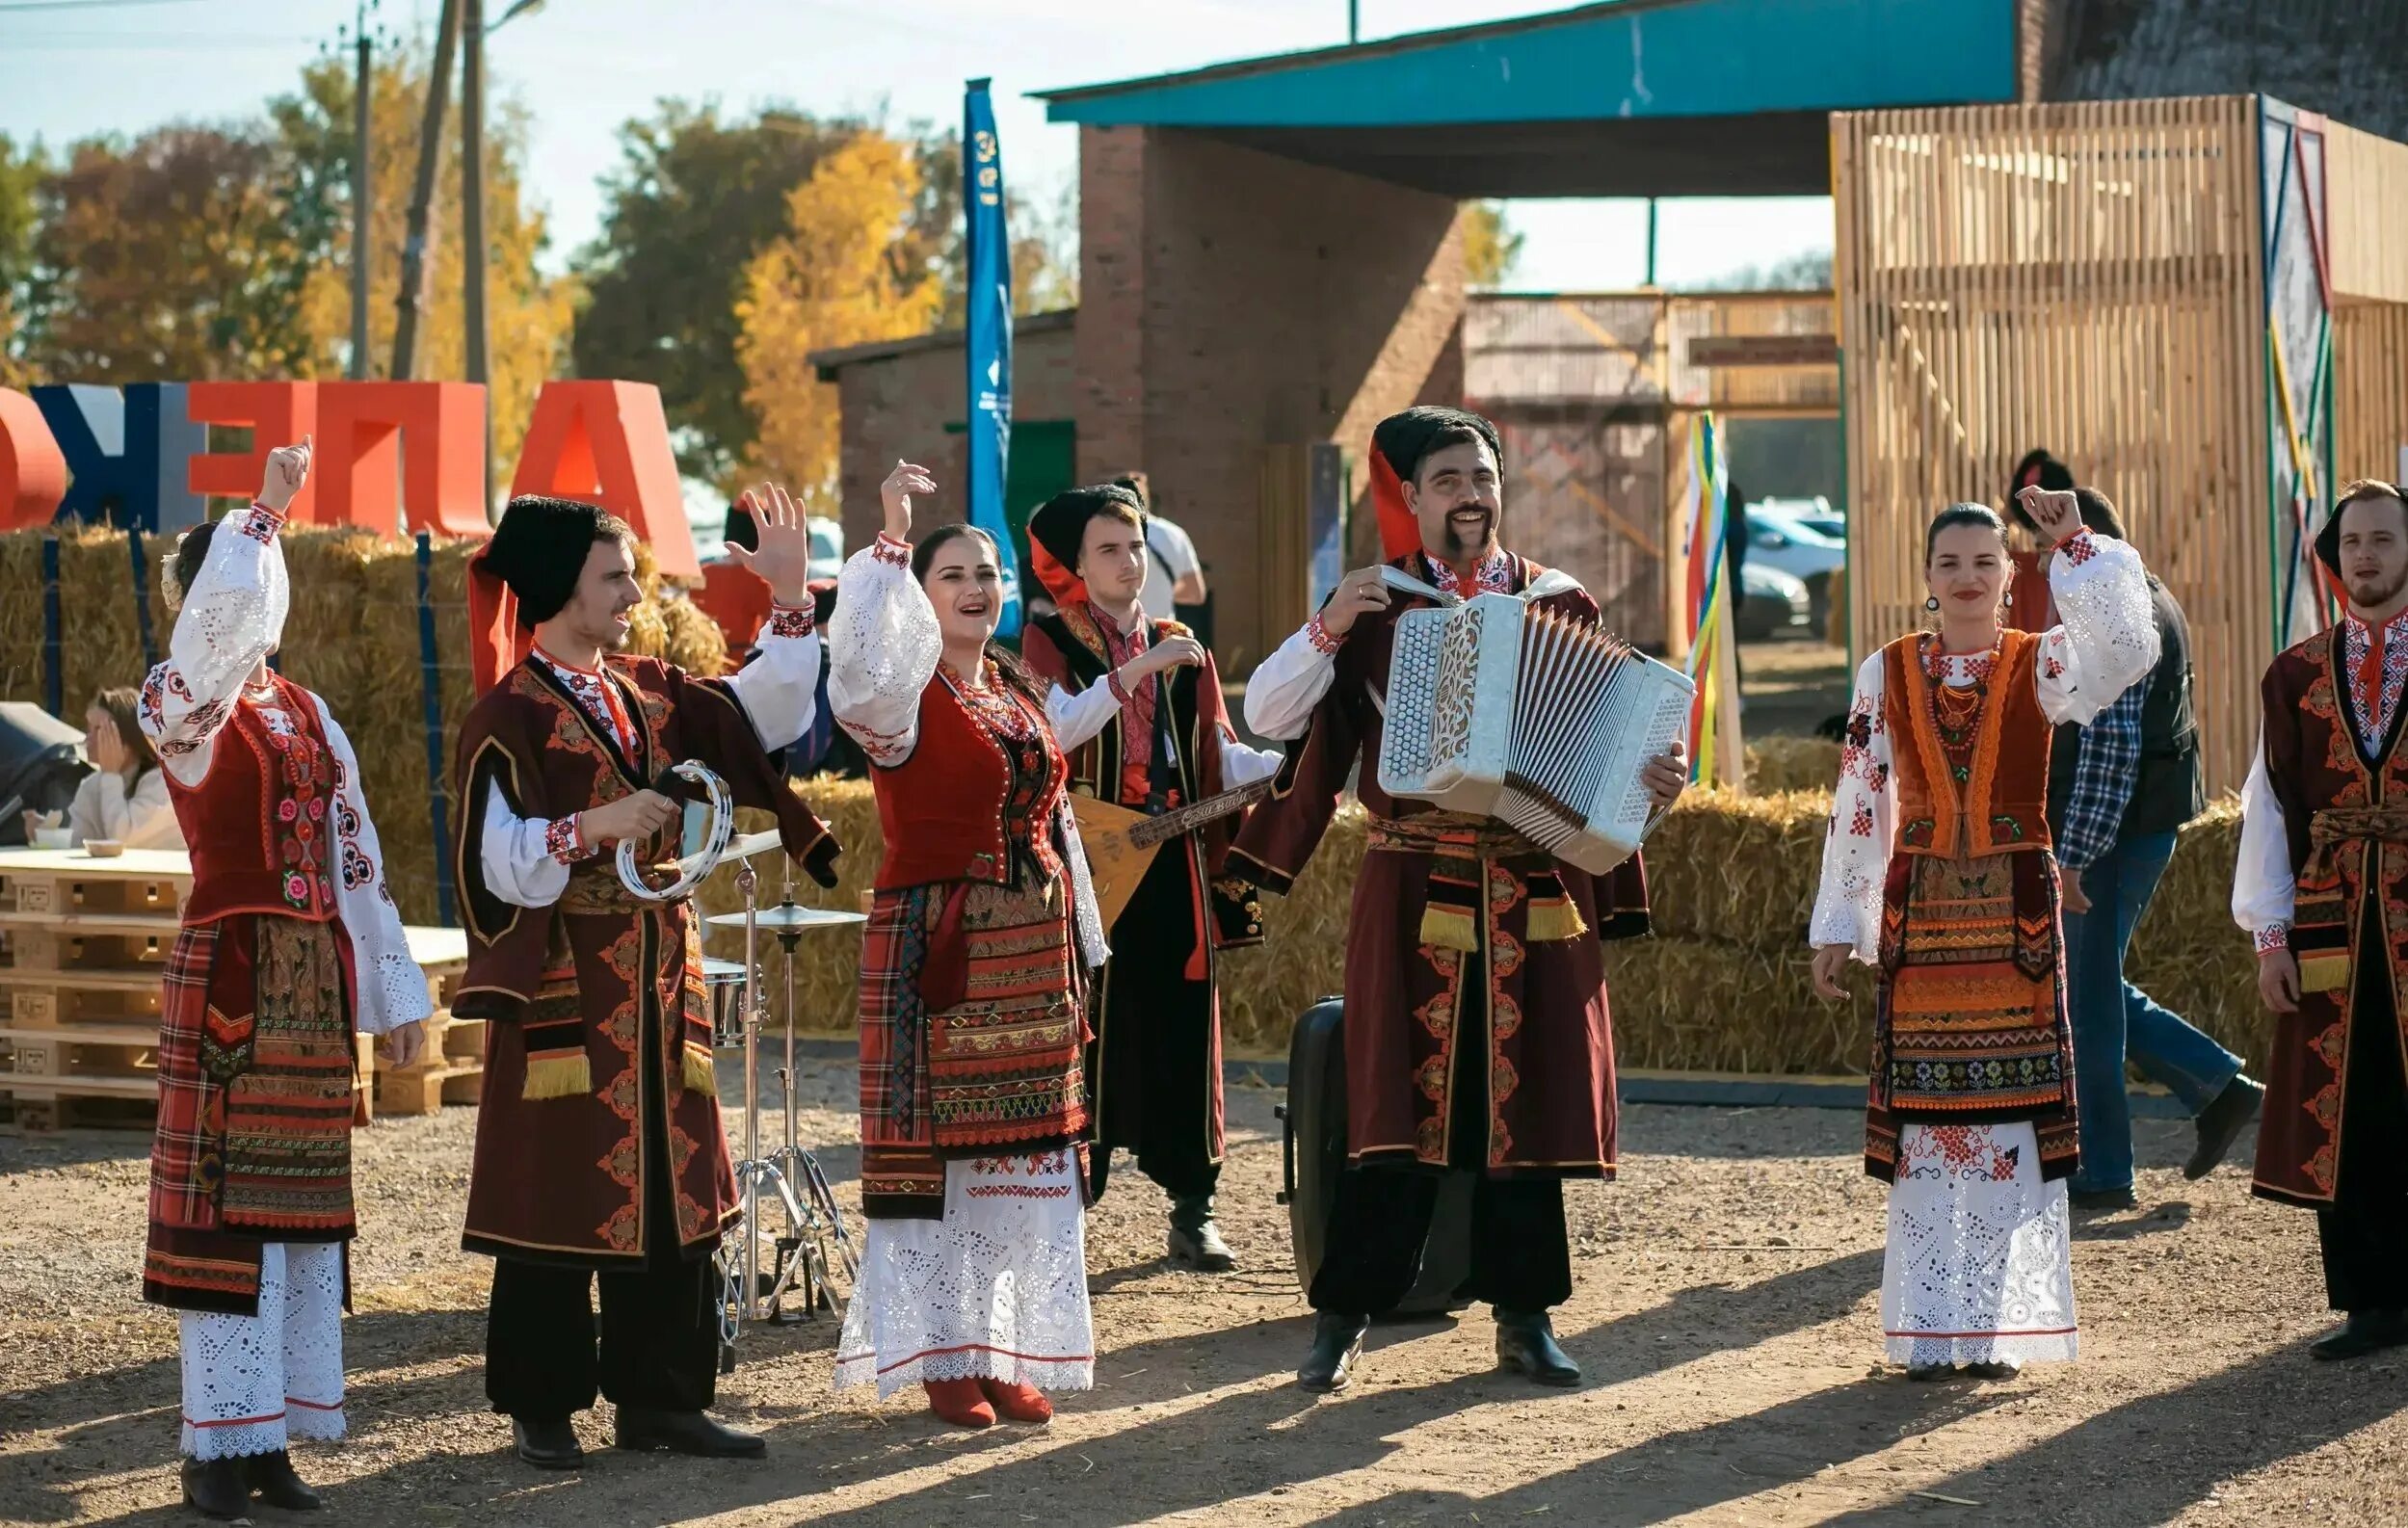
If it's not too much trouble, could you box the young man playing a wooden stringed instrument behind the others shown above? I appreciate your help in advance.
[1021,484,1279,1273]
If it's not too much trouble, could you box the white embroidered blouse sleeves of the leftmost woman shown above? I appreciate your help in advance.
[135,506,434,1035]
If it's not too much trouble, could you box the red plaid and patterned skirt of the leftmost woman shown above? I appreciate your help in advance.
[142,914,354,1314]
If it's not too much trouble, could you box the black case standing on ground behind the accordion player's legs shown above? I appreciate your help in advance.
[1279,996,1476,1316]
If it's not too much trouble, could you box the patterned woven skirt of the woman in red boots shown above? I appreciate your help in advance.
[862,881,1089,1218]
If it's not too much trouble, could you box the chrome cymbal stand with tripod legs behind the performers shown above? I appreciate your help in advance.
[718,859,860,1374]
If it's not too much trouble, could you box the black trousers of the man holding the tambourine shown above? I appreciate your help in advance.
[484,972,720,1422]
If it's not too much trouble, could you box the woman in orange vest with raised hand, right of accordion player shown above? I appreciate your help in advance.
[1809,487,2157,1379]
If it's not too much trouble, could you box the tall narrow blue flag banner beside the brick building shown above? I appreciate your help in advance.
[961,79,1021,643]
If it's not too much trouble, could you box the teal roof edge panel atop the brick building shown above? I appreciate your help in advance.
[1038,0,2016,130]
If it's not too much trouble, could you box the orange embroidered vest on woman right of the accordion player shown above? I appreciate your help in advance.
[1881,630,2054,859]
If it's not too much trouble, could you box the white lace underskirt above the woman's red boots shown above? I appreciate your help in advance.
[835,1150,1096,1401]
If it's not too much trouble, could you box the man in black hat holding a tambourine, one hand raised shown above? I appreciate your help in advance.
[453,491,835,1468]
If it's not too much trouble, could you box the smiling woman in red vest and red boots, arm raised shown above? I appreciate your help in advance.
[829,462,1105,1427]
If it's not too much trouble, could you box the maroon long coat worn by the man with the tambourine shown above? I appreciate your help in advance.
[453,657,835,1268]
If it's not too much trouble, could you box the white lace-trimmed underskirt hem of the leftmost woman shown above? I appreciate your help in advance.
[180,1242,344,1459]
